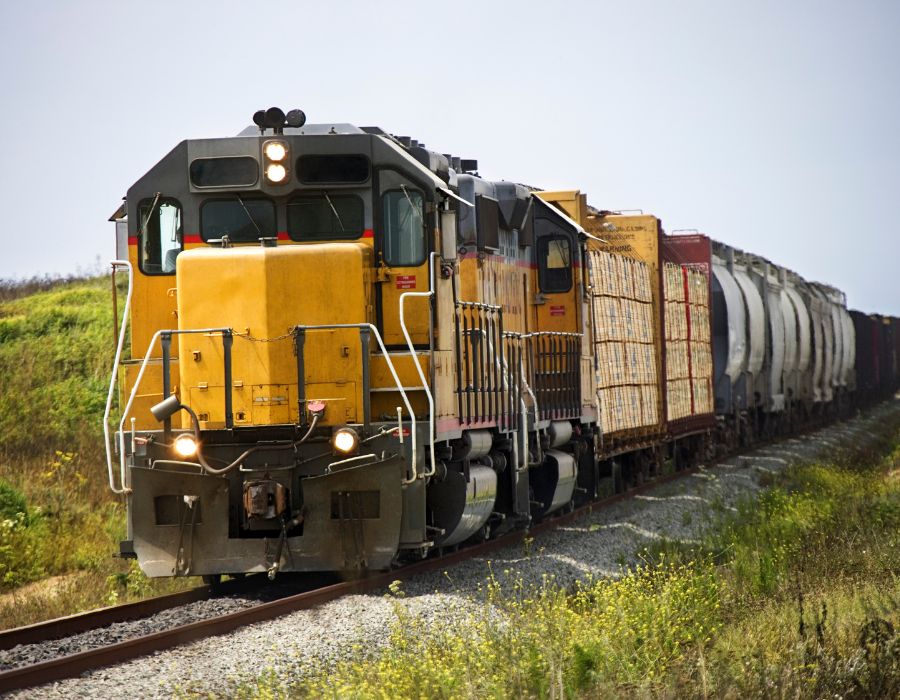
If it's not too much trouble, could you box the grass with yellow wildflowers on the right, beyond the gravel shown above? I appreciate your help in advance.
[218,411,900,698]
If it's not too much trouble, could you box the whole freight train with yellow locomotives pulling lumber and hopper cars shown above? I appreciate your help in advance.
[103,107,900,581]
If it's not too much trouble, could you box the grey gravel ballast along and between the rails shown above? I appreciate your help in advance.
[8,401,900,698]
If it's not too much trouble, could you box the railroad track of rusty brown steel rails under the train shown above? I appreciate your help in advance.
[0,460,696,693]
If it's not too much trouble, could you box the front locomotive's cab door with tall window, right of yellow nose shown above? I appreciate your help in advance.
[375,170,431,348]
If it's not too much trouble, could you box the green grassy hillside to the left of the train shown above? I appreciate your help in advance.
[0,277,192,628]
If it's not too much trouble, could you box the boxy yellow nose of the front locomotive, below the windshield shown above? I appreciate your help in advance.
[177,242,372,429]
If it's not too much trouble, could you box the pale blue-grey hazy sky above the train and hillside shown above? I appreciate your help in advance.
[0,0,900,315]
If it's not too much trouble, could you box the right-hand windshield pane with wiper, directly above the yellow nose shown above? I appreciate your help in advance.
[287,192,363,241]
